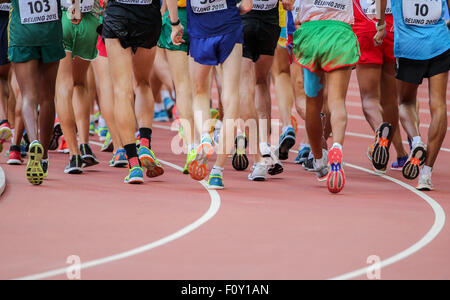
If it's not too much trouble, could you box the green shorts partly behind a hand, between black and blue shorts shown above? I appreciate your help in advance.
[158,7,189,53]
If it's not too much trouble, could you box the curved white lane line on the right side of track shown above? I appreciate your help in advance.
[289,150,446,280]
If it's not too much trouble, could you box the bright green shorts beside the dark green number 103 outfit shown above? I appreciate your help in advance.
[62,10,98,60]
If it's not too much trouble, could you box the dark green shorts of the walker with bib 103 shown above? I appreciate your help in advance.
[8,43,66,64]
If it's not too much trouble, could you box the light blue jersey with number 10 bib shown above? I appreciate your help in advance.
[391,0,450,60]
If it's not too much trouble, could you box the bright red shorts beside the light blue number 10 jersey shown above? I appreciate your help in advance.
[356,31,395,65]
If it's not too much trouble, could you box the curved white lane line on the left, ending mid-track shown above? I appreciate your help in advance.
[16,146,221,280]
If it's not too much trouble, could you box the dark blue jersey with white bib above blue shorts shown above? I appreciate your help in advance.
[187,0,242,38]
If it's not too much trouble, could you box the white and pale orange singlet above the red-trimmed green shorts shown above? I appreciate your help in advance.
[298,0,354,24]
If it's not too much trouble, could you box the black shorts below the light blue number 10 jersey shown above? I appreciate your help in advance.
[395,49,450,84]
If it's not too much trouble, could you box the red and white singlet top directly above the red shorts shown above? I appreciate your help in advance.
[353,0,394,34]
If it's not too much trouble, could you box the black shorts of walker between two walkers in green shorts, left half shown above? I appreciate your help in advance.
[102,1,162,53]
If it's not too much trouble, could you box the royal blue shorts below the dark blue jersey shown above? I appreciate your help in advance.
[189,27,244,66]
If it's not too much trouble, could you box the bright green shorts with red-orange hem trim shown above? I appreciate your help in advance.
[294,20,361,72]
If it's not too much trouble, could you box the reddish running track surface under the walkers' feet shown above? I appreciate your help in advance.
[0,74,450,279]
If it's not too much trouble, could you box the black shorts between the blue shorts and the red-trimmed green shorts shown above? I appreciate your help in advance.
[242,19,281,62]
